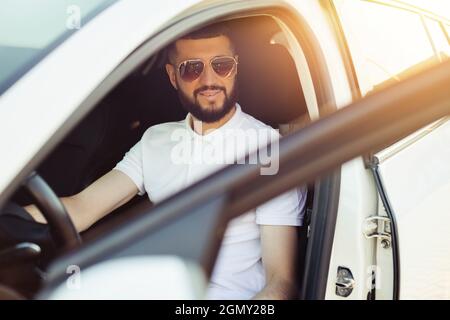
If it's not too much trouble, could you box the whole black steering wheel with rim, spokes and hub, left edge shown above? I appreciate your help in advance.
[0,172,81,299]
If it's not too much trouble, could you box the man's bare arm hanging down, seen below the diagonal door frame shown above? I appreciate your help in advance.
[253,225,297,300]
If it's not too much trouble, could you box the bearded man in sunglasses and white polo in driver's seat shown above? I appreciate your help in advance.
[26,24,305,299]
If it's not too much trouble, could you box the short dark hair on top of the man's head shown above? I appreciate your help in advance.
[166,22,235,63]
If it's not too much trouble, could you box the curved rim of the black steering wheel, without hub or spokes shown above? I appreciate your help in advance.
[23,172,81,250]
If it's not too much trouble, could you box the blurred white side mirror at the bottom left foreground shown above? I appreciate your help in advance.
[36,256,207,300]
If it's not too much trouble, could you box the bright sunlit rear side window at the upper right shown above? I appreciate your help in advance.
[334,0,436,95]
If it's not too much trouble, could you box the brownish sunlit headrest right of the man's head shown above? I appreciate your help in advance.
[238,43,307,128]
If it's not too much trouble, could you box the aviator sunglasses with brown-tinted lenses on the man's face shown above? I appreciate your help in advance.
[178,56,238,82]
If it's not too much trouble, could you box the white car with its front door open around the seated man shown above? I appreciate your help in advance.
[0,0,450,300]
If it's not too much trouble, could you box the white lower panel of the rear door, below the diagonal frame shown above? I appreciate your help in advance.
[377,118,450,299]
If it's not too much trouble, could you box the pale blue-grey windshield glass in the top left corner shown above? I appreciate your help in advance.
[0,0,116,94]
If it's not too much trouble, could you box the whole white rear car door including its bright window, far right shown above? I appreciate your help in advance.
[333,0,450,299]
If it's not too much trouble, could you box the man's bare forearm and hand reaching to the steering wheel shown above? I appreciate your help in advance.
[24,170,139,232]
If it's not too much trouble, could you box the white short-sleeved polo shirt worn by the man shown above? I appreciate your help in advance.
[114,104,306,299]
